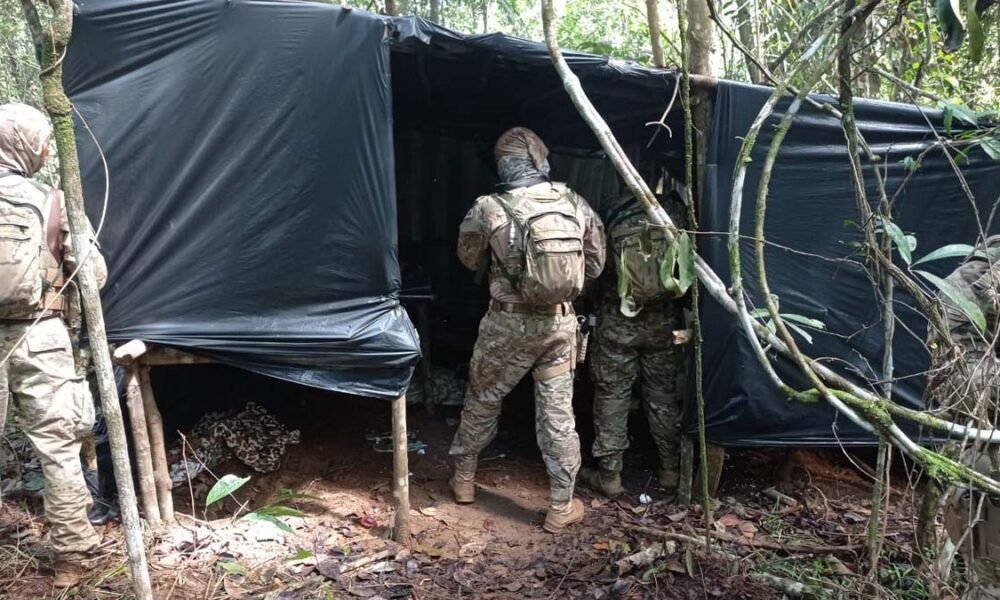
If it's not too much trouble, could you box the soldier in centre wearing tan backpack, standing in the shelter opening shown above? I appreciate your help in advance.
[450,127,605,533]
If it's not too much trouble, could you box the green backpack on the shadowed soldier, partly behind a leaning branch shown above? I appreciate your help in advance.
[606,198,690,317]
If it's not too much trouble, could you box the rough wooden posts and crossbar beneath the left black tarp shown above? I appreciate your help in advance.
[114,340,410,544]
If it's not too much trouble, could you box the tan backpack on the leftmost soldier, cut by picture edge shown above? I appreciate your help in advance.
[0,173,46,318]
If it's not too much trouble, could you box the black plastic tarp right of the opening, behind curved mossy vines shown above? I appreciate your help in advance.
[700,82,1000,446]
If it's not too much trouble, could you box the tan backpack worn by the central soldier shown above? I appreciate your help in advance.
[493,184,585,305]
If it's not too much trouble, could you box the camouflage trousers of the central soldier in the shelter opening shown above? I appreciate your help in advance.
[450,309,580,508]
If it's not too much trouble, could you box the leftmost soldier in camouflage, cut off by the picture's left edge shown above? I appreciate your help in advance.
[0,104,107,587]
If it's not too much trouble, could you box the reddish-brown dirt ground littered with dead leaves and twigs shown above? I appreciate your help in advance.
[0,382,930,600]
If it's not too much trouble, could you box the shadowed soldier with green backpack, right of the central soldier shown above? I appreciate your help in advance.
[580,178,687,496]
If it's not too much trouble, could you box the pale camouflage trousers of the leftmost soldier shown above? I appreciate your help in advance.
[0,317,101,556]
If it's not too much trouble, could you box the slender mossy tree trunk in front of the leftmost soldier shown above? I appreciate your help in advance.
[22,0,153,600]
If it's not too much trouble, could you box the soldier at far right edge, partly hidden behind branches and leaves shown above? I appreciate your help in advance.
[921,236,1000,599]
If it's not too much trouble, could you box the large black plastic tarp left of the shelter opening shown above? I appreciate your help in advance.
[65,0,419,397]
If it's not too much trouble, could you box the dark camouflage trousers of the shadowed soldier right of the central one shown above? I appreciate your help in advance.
[590,302,682,480]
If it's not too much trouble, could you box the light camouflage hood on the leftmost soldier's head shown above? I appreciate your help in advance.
[0,104,52,177]
